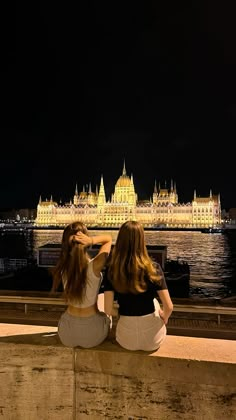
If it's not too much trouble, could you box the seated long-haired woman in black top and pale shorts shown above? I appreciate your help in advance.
[104,221,173,351]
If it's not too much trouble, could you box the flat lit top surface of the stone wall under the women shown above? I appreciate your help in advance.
[0,323,236,364]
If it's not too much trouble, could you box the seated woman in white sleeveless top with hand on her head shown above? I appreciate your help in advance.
[52,221,112,348]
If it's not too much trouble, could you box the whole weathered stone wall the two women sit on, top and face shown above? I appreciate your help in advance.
[0,324,236,420]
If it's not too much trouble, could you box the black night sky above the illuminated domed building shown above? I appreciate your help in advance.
[0,0,236,209]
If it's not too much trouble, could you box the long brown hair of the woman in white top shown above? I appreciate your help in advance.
[52,221,88,301]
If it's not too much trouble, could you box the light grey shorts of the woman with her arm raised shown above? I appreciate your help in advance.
[58,312,111,348]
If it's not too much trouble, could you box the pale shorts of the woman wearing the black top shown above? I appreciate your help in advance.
[116,302,166,351]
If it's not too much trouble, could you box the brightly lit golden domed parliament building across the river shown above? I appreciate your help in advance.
[35,163,221,229]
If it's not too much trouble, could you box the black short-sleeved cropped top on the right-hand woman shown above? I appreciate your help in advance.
[103,264,167,316]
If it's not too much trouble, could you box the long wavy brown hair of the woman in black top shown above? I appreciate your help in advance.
[108,221,161,293]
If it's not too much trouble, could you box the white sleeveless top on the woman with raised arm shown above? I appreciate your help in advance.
[62,259,102,308]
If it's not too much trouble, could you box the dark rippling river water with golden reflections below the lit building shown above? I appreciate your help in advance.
[0,229,236,299]
